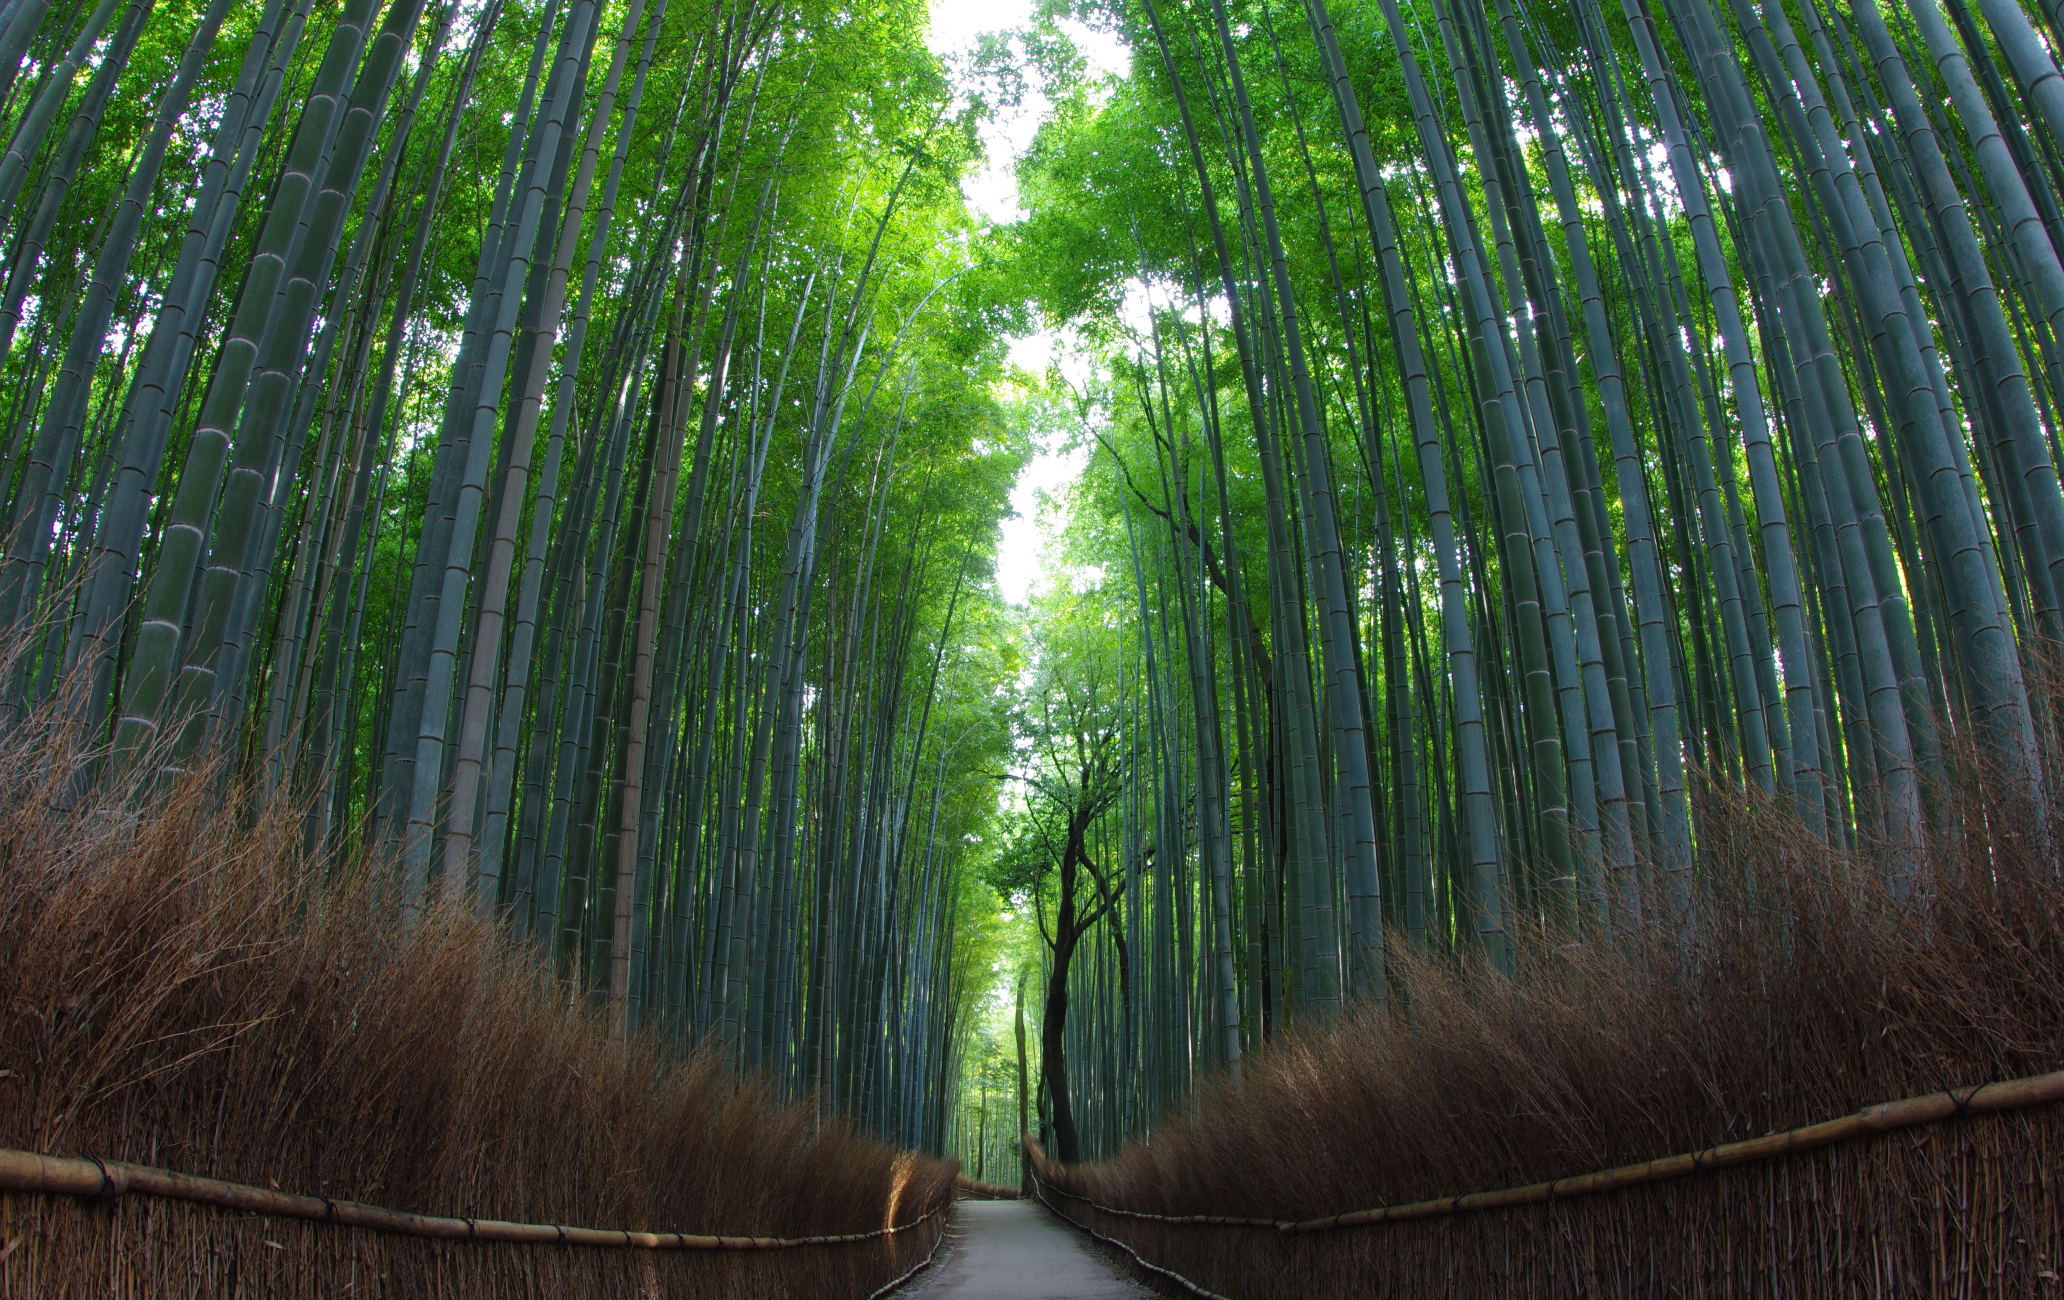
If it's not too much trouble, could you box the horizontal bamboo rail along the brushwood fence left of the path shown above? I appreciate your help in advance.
[0,1147,954,1250]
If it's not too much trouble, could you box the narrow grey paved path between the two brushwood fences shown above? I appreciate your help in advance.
[898,1201,1154,1300]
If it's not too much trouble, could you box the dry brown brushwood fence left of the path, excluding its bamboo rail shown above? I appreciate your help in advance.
[0,697,956,1300]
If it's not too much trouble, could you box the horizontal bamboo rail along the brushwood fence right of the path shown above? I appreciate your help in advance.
[1034,1069,2064,1238]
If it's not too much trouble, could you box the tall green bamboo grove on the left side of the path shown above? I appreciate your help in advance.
[0,0,1020,1147]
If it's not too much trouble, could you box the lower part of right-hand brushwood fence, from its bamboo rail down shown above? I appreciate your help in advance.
[1026,1071,2064,1300]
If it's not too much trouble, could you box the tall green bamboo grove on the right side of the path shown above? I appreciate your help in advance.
[1001,0,2064,1160]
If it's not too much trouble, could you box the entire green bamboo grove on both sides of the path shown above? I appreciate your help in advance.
[0,0,2064,1221]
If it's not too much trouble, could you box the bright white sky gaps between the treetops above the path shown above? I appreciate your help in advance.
[931,0,1129,605]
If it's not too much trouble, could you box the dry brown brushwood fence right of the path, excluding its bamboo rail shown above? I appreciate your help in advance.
[1046,757,2064,1296]
